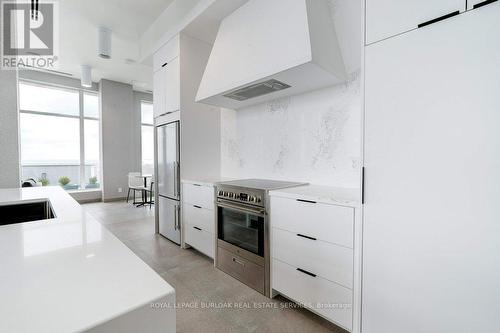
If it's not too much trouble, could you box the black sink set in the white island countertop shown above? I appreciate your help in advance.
[0,200,55,225]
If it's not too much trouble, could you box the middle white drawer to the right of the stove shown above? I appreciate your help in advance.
[271,228,354,289]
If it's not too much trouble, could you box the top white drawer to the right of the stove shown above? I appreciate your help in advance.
[271,196,354,248]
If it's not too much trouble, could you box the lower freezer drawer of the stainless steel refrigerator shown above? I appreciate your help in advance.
[158,195,181,244]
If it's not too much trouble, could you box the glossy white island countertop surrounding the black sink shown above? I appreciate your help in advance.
[0,186,175,333]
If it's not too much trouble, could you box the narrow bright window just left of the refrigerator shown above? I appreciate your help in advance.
[141,101,154,174]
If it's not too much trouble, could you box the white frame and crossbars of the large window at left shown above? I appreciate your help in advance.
[18,78,102,192]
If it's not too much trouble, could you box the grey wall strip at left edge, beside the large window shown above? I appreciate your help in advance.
[0,70,20,188]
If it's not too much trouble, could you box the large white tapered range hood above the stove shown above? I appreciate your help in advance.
[196,0,346,109]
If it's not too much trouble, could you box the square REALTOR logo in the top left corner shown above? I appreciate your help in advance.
[1,0,59,69]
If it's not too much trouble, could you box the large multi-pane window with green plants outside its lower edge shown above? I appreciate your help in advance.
[19,81,100,190]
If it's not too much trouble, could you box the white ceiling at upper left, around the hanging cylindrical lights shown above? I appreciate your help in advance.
[39,0,173,90]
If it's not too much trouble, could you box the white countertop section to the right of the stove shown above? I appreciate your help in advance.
[269,185,360,207]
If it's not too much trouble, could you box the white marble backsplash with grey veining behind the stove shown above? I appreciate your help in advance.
[221,71,361,187]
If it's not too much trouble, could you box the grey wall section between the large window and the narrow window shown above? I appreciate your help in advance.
[99,80,141,201]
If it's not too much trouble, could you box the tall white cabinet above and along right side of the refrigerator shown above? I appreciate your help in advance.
[153,33,220,240]
